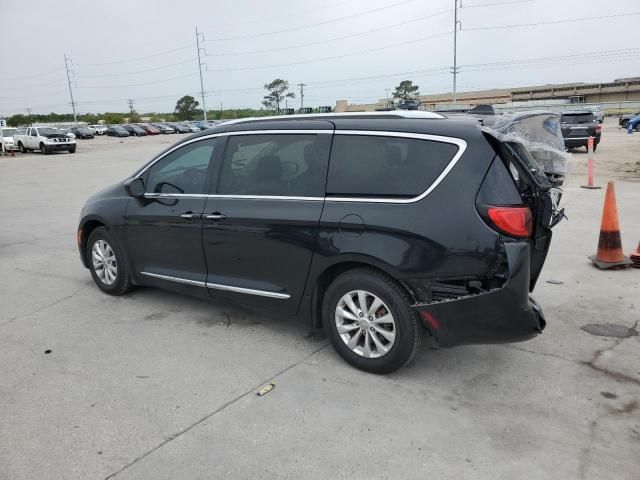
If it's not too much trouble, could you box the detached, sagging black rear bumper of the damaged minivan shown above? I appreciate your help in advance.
[412,242,546,347]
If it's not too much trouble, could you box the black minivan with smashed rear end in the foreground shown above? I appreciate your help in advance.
[78,112,553,373]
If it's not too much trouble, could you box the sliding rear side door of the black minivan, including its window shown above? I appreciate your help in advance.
[202,131,332,315]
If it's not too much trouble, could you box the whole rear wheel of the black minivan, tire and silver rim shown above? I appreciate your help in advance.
[322,268,423,373]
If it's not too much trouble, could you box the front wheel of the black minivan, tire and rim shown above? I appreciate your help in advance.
[86,227,133,295]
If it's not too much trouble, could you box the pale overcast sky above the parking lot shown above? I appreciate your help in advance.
[0,0,640,117]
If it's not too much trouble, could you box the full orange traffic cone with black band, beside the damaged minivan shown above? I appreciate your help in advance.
[589,182,631,269]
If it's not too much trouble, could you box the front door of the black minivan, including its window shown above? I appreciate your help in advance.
[125,138,223,295]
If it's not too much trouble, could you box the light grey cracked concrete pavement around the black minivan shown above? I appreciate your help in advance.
[0,125,640,480]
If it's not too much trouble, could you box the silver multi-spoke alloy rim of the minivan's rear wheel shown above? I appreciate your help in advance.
[335,290,396,358]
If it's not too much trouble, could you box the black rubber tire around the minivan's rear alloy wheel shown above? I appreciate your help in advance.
[322,268,424,374]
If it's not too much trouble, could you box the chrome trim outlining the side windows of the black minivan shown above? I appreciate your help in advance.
[135,130,467,204]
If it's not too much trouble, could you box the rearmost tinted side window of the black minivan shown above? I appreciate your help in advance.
[327,135,458,197]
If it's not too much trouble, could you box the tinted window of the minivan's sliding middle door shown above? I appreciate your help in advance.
[218,134,330,197]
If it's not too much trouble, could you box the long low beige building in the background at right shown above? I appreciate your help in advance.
[335,77,640,112]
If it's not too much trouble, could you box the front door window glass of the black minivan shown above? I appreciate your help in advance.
[146,139,218,193]
